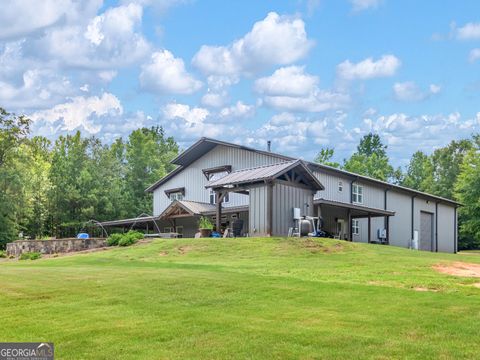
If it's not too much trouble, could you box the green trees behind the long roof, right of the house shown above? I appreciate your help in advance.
[315,133,480,249]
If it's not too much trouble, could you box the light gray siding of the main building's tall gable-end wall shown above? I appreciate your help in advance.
[153,145,283,216]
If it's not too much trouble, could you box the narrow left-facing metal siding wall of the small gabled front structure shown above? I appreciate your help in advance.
[248,185,268,236]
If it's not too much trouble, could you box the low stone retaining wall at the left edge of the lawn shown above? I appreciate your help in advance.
[7,238,107,257]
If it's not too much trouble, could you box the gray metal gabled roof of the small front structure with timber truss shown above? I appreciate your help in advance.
[206,160,324,190]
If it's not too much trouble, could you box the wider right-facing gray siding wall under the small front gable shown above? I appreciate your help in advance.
[272,184,314,236]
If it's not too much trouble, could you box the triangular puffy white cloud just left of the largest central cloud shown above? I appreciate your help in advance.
[140,50,202,94]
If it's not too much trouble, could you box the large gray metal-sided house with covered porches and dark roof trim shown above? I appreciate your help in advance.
[103,138,459,253]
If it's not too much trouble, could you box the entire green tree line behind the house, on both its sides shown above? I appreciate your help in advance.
[0,108,480,249]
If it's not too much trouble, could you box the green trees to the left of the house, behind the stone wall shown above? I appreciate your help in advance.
[0,108,179,249]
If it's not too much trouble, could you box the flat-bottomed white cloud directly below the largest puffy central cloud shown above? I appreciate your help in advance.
[255,66,318,96]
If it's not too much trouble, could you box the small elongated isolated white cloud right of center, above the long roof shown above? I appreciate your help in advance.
[337,55,401,80]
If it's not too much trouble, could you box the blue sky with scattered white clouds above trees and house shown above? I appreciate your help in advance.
[0,0,480,165]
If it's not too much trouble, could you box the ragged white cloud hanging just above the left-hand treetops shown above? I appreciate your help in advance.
[29,93,123,134]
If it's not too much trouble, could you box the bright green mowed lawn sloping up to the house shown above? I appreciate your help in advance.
[0,238,480,359]
